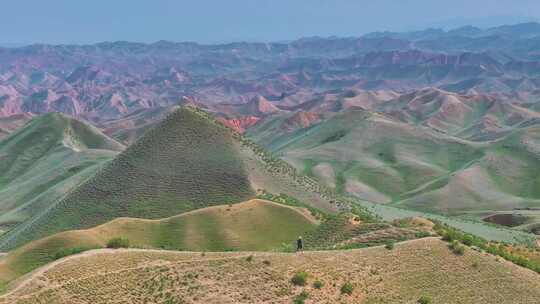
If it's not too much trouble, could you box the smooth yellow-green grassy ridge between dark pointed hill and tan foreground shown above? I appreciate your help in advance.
[0,200,317,282]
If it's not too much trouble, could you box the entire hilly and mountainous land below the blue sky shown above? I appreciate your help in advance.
[0,23,540,303]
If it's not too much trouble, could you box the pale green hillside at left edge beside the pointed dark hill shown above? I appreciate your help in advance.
[0,113,124,233]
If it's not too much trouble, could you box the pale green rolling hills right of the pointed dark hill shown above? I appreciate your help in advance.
[249,109,540,234]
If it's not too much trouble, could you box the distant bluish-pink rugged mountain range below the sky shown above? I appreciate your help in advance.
[0,23,540,121]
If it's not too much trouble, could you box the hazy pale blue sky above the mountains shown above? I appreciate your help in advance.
[0,0,540,43]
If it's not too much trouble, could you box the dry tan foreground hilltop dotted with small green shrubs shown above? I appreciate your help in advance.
[0,238,540,304]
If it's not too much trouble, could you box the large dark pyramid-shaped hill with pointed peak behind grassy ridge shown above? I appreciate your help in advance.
[0,107,340,249]
